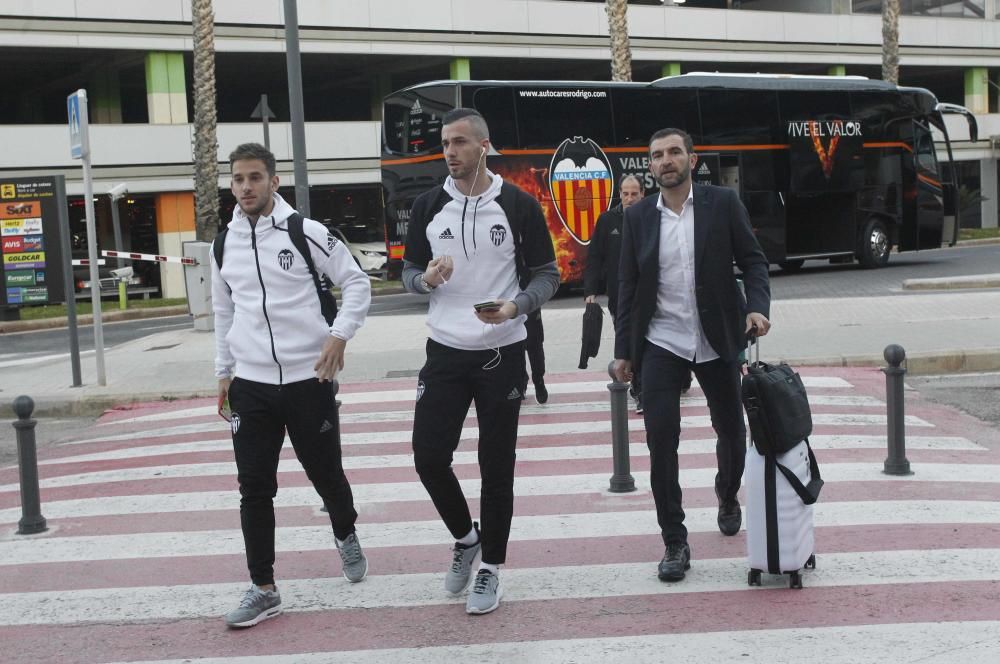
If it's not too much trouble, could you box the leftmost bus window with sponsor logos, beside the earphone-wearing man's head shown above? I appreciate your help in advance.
[382,85,455,154]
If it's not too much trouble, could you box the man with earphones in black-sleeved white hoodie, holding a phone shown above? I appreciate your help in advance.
[403,108,559,614]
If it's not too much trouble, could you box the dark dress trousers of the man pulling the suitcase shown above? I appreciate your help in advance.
[642,342,746,544]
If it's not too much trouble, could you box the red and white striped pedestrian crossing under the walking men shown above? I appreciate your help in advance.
[0,368,1000,662]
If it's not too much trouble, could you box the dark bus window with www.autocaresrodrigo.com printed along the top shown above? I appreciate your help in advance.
[514,86,612,149]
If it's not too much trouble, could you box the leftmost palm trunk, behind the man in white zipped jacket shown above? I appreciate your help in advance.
[191,0,219,242]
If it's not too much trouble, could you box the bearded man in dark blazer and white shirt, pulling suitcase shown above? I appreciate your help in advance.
[614,129,771,581]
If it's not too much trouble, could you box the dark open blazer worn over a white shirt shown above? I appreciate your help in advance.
[615,184,771,370]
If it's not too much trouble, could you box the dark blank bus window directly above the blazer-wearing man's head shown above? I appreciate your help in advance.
[611,88,701,148]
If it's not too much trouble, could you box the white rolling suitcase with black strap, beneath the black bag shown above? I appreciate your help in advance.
[744,440,822,588]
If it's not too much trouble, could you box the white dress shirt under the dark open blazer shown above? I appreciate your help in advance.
[646,186,719,363]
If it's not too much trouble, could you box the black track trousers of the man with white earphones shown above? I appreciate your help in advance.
[413,339,527,565]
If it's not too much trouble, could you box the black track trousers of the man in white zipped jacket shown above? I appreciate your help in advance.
[229,378,358,586]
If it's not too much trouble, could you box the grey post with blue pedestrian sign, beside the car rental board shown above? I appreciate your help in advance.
[66,89,108,386]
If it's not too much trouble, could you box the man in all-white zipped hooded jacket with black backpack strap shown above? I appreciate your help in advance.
[212,143,371,627]
